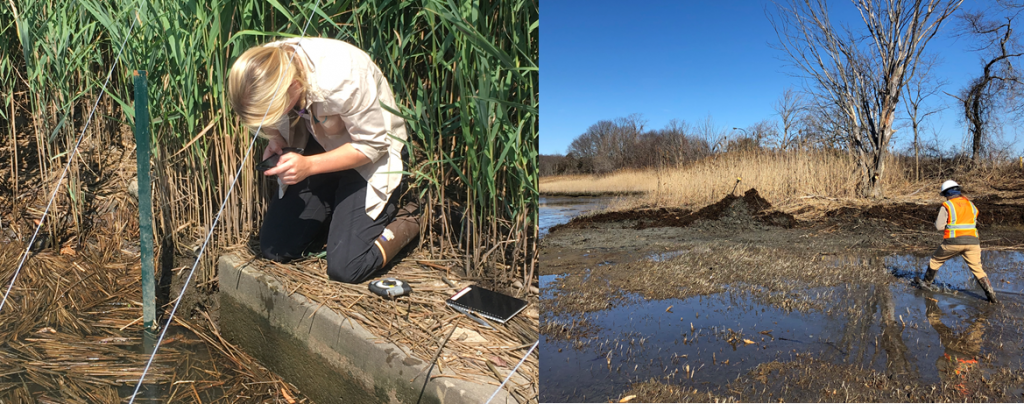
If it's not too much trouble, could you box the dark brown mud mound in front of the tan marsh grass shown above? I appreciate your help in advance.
[551,188,797,232]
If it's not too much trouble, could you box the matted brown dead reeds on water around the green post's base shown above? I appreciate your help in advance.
[0,245,284,402]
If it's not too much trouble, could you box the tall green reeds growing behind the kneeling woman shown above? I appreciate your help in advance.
[0,0,540,282]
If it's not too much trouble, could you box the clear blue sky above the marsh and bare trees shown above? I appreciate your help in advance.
[541,0,1015,154]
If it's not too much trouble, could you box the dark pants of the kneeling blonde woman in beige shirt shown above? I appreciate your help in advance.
[259,136,400,283]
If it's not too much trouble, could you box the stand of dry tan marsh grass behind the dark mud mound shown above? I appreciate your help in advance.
[541,151,931,213]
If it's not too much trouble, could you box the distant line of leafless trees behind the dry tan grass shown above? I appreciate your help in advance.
[538,89,1015,179]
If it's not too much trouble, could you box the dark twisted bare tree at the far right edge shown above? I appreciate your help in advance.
[954,11,1022,167]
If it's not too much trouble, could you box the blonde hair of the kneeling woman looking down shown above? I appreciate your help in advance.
[227,46,306,127]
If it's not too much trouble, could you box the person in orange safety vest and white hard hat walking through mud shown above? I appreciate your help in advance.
[918,180,998,303]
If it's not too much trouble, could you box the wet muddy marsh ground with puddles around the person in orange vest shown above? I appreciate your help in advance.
[541,191,1024,402]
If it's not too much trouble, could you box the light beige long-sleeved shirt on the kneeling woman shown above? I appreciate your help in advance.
[264,38,409,219]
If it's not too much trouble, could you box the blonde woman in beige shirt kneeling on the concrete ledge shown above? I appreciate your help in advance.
[227,38,419,283]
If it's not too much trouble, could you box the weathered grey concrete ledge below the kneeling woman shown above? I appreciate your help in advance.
[218,255,507,404]
